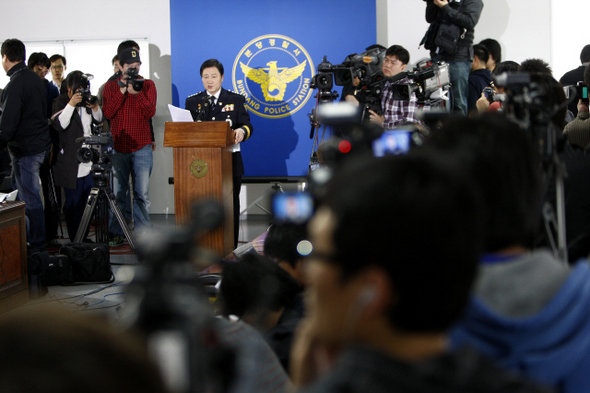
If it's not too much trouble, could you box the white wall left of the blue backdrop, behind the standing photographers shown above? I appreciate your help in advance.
[0,0,174,214]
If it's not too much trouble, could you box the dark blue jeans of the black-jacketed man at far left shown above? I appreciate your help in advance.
[12,152,48,249]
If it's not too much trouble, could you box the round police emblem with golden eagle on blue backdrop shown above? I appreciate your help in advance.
[232,34,314,118]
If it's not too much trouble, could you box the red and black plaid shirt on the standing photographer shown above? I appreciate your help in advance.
[102,78,157,153]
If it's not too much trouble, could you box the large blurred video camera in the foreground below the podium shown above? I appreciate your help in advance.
[121,200,236,393]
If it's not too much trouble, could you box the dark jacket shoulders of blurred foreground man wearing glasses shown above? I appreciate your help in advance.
[303,346,551,393]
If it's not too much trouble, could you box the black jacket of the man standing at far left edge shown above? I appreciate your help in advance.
[0,62,51,157]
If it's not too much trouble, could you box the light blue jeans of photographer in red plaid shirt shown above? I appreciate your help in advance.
[109,144,154,236]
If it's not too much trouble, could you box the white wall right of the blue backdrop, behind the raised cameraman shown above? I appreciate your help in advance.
[377,0,590,79]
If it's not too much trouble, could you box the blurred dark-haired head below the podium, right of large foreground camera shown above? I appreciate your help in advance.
[219,253,299,331]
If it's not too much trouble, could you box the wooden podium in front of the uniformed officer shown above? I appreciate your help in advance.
[164,121,234,255]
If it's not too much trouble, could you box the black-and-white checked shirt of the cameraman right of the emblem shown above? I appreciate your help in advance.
[381,78,423,130]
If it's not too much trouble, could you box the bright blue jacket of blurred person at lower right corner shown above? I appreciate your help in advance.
[451,262,590,393]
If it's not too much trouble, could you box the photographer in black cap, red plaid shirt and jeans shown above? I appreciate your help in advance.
[103,48,157,245]
